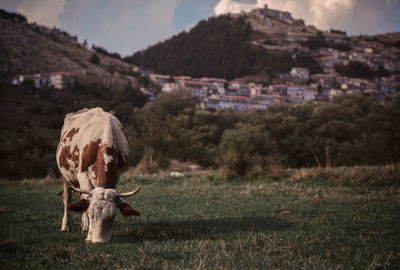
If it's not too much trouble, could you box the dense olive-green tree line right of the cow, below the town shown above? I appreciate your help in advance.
[126,91,400,175]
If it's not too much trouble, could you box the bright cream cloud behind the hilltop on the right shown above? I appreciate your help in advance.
[215,0,400,34]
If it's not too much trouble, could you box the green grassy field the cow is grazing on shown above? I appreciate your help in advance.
[0,168,400,269]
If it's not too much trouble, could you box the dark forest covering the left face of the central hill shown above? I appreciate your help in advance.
[125,15,300,80]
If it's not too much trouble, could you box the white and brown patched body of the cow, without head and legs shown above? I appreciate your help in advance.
[57,108,128,186]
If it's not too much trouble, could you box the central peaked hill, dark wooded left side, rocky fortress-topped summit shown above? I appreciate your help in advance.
[124,8,400,80]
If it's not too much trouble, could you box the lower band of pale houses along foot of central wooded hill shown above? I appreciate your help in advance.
[150,68,400,111]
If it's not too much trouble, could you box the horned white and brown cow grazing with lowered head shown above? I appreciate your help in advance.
[57,108,140,243]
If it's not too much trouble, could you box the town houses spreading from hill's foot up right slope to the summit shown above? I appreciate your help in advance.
[141,3,400,110]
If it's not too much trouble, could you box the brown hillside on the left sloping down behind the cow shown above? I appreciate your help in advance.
[0,10,152,179]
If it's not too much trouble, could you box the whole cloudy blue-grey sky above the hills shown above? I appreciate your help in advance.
[0,0,400,56]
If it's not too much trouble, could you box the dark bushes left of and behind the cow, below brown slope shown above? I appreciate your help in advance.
[0,84,147,179]
